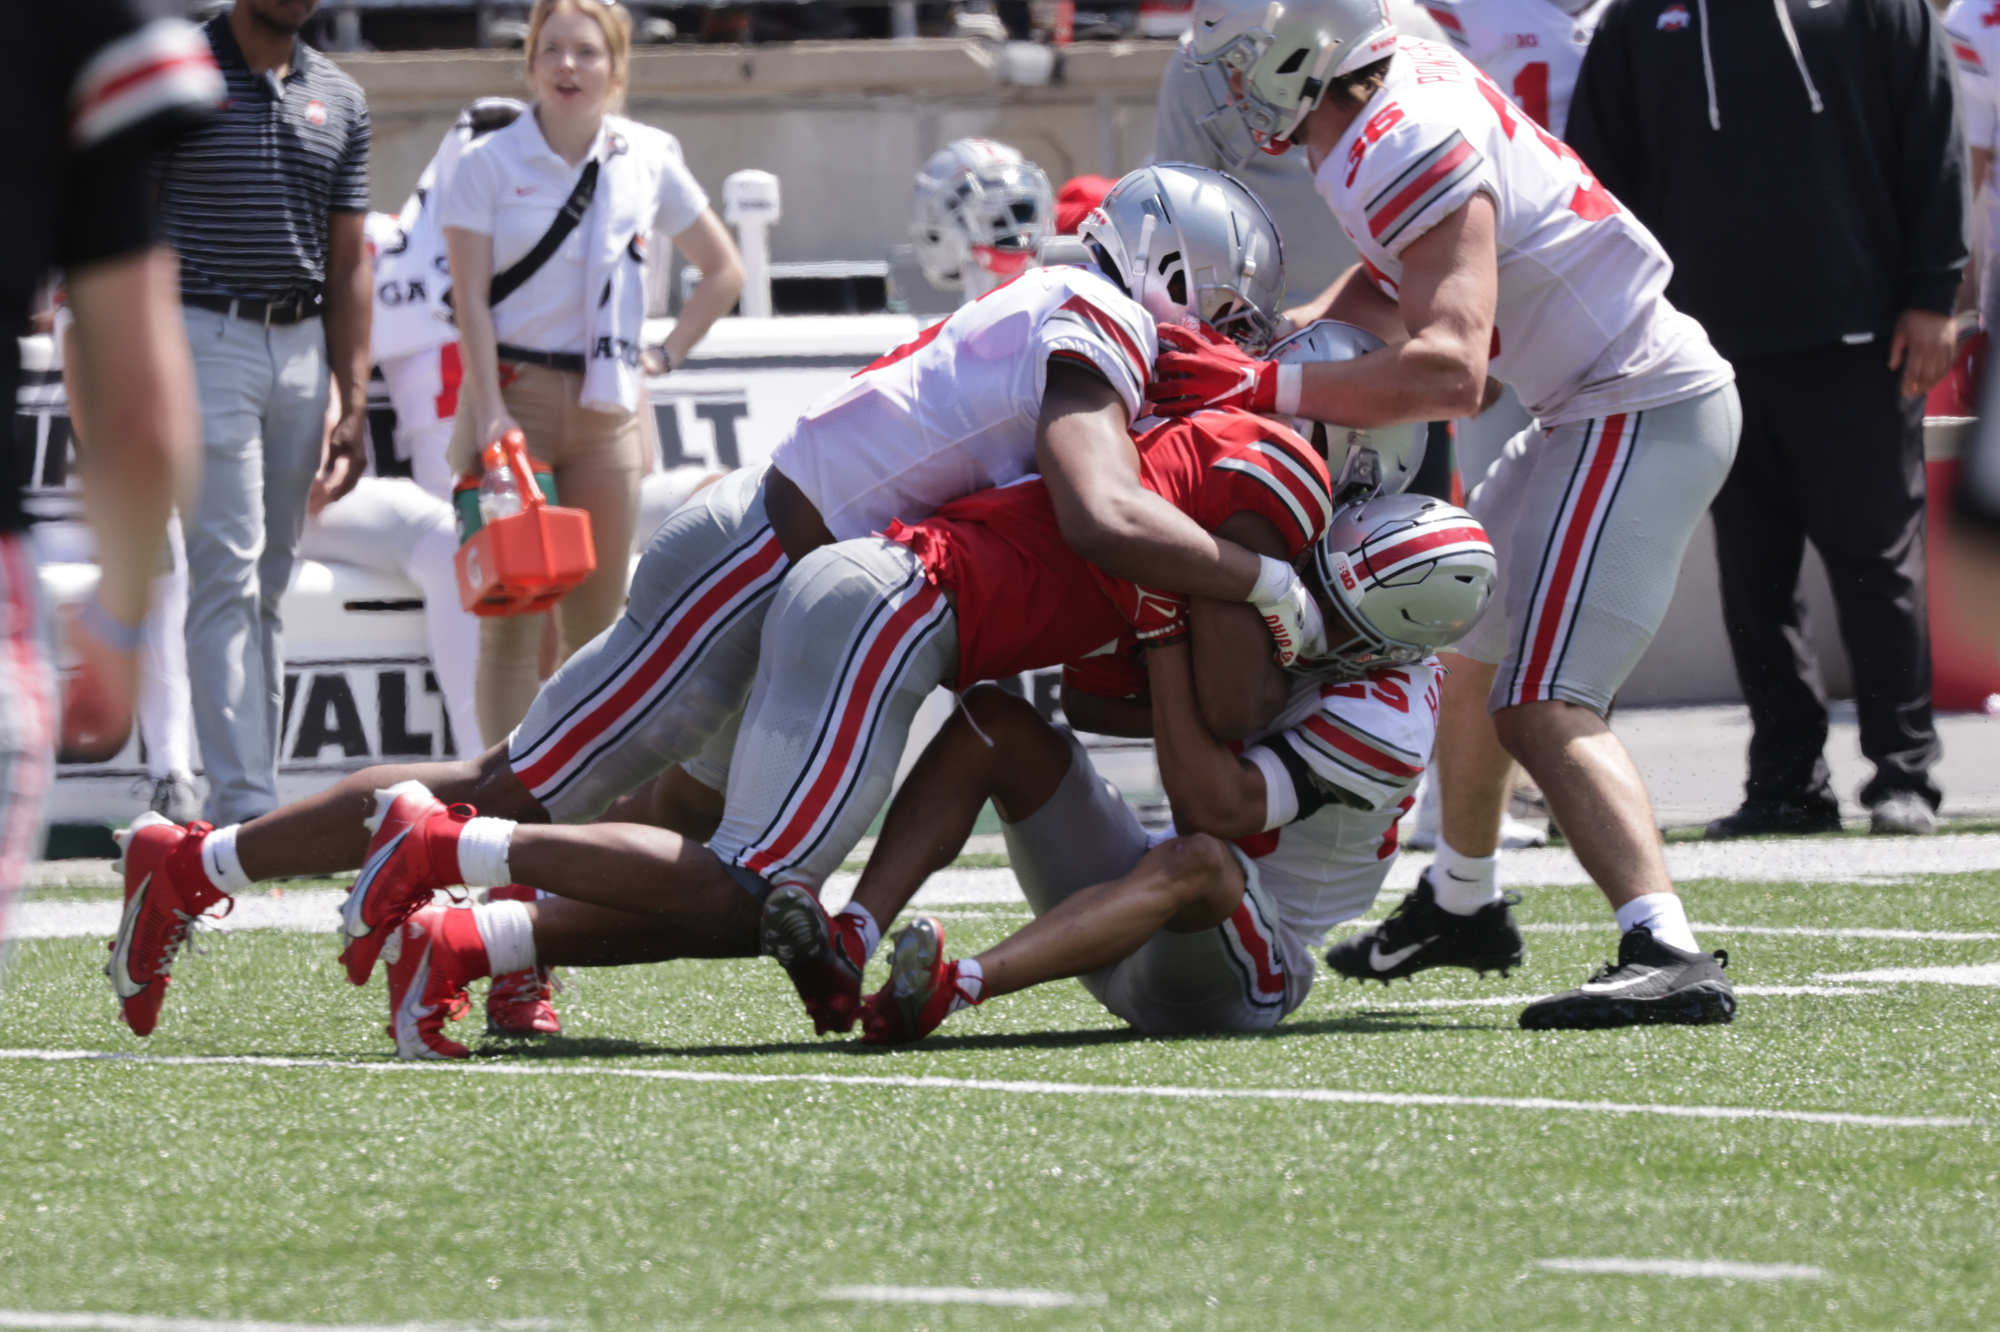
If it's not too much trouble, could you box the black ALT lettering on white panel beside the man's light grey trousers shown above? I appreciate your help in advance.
[278,658,462,770]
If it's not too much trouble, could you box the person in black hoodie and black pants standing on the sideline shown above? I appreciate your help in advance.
[1568,0,1966,838]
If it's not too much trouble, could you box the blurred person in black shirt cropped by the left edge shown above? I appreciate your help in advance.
[0,0,222,972]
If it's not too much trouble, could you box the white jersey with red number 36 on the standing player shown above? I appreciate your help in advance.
[1316,38,1734,426]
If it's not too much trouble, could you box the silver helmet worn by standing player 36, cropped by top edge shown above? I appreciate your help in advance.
[1194,0,1396,152]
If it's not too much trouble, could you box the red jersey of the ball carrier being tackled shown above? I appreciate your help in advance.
[888,410,1334,690]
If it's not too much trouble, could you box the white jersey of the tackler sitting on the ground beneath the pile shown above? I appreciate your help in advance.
[1236,658,1444,948]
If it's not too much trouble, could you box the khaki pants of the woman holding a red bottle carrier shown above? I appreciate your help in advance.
[450,362,644,744]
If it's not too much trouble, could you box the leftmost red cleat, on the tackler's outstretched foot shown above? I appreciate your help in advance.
[104,812,236,1036]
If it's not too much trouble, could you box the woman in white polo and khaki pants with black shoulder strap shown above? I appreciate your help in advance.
[440,0,742,740]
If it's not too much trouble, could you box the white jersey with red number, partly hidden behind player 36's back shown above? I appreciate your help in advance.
[1424,0,1612,138]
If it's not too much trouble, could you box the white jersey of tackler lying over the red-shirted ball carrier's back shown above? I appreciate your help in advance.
[770,264,1160,540]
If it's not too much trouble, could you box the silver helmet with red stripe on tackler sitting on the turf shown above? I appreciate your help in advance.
[1292,494,1500,680]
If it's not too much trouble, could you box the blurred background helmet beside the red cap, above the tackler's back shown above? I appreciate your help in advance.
[910,138,1056,294]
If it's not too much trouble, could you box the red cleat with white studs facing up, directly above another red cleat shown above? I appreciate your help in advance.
[340,782,476,986]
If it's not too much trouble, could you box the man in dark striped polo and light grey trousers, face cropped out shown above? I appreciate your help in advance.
[158,0,370,822]
